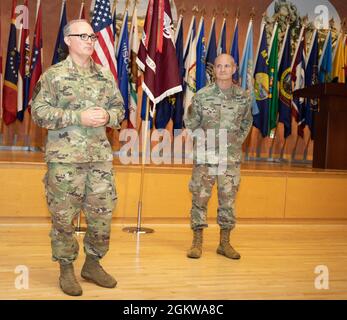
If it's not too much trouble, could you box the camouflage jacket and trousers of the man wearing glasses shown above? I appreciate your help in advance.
[31,56,124,264]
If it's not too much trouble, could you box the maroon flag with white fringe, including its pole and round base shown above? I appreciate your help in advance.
[123,0,182,234]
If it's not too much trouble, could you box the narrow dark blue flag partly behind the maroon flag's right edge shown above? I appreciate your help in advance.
[172,18,184,129]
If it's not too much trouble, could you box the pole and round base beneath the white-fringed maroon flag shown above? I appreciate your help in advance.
[123,97,154,233]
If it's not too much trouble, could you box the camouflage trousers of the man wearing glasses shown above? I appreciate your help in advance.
[44,162,117,264]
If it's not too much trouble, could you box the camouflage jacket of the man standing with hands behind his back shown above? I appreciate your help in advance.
[185,83,253,164]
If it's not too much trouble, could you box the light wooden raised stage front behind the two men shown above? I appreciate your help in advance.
[0,151,347,223]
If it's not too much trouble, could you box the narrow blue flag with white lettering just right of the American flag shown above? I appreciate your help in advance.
[117,11,129,119]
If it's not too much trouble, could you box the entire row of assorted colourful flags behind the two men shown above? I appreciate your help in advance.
[0,0,347,138]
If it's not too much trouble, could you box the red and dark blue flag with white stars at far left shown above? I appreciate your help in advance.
[3,0,19,125]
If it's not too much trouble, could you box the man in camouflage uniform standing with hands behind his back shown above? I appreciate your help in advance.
[185,54,252,259]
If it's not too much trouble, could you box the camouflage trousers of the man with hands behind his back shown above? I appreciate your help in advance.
[189,163,240,230]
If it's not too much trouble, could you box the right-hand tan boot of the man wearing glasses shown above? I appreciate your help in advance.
[81,255,117,288]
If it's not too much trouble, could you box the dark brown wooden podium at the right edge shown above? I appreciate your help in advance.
[293,83,347,170]
